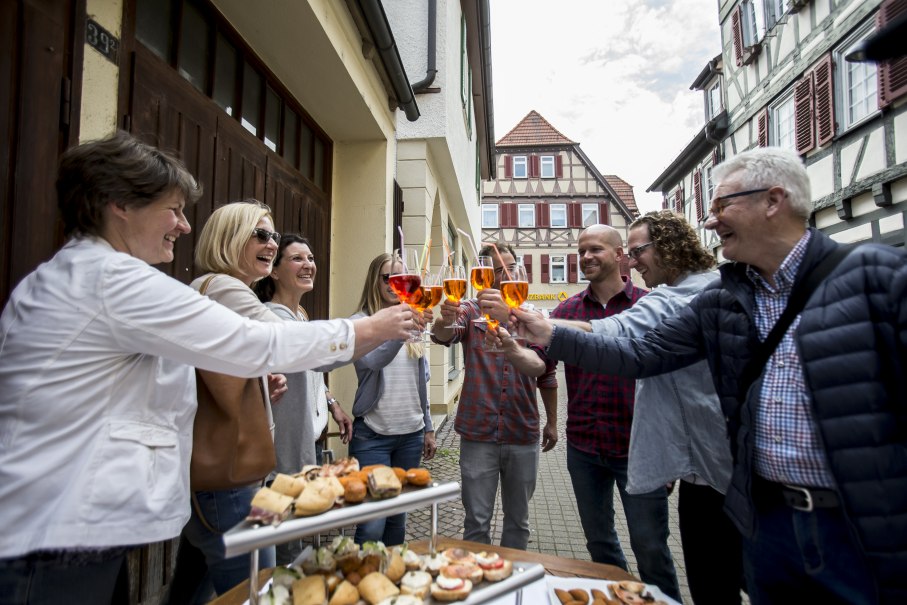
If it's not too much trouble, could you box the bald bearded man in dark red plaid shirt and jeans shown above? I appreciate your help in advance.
[551,225,680,598]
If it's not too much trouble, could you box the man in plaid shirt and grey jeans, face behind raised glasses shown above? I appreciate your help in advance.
[432,243,557,550]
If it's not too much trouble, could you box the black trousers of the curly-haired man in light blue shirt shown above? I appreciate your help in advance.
[677,481,743,605]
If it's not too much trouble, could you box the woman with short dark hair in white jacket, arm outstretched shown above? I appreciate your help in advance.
[0,132,414,604]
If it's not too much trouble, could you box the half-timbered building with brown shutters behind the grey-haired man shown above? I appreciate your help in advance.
[649,0,907,259]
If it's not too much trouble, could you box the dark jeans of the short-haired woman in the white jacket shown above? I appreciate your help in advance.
[0,552,128,605]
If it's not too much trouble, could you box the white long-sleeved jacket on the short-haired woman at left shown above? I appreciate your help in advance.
[0,238,355,558]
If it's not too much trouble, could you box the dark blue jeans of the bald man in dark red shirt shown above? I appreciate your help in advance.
[567,443,680,601]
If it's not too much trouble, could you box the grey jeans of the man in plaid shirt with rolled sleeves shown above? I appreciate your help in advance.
[460,439,539,550]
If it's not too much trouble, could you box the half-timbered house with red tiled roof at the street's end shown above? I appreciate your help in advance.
[482,111,639,312]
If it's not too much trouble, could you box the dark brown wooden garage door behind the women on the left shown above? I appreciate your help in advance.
[125,44,330,318]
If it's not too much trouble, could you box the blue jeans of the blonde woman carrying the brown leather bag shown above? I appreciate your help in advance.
[174,486,276,595]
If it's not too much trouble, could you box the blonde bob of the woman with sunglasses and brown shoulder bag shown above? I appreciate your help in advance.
[195,199,274,275]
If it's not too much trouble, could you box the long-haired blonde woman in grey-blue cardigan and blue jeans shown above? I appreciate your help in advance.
[350,254,435,546]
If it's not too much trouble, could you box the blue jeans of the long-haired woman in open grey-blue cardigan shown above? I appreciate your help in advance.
[350,418,425,546]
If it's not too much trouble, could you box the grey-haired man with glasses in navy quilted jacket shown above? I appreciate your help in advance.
[514,148,907,605]
